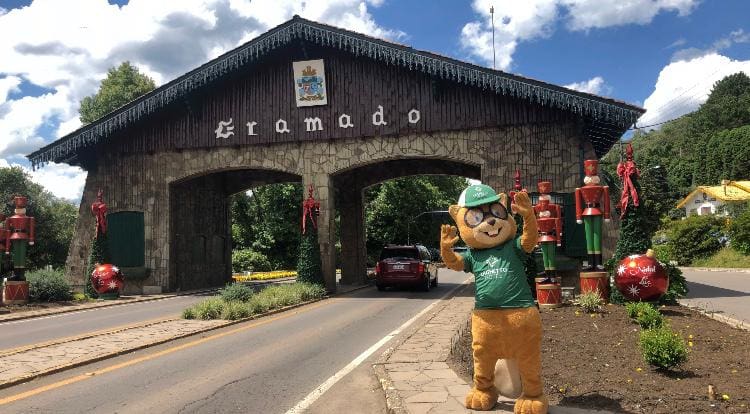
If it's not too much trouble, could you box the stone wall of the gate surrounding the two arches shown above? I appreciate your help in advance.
[66,124,595,291]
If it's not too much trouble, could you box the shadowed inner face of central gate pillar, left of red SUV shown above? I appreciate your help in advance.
[338,185,367,284]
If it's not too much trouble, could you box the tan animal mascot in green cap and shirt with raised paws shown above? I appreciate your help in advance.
[440,184,548,414]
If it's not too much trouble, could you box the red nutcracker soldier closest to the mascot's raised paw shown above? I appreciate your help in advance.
[534,181,562,283]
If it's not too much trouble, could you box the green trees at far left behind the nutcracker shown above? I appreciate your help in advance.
[0,167,78,269]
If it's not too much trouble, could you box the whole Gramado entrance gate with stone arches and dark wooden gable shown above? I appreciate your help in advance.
[29,17,643,291]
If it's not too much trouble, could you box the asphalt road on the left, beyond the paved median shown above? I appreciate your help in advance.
[0,294,216,352]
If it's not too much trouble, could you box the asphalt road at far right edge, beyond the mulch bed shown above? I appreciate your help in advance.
[680,269,750,325]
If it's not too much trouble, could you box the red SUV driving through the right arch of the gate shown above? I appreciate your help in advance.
[375,244,437,292]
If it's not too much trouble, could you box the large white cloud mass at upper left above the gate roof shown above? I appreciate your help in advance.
[0,0,405,198]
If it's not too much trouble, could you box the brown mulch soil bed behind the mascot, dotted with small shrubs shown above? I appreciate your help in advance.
[450,305,750,413]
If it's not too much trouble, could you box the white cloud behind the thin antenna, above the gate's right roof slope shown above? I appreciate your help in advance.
[460,0,699,70]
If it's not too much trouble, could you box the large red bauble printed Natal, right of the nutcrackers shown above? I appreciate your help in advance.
[615,254,669,301]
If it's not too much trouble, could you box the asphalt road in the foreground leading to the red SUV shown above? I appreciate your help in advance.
[0,269,467,413]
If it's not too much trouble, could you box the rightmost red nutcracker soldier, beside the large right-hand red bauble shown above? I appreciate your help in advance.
[576,160,609,271]
